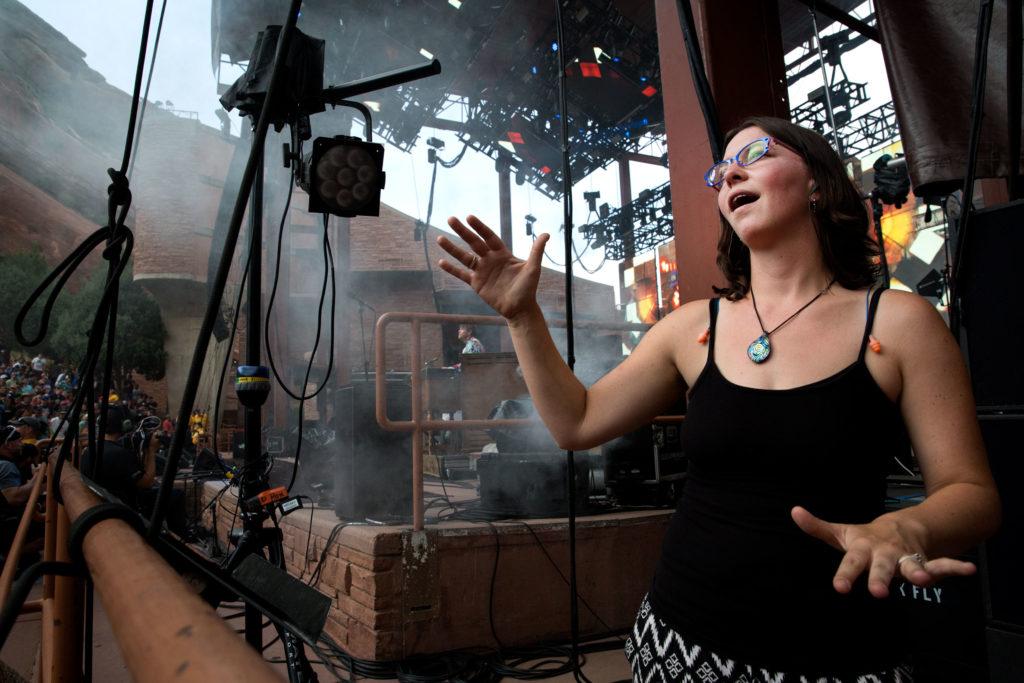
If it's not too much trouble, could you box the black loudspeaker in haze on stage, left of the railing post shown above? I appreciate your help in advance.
[334,378,413,519]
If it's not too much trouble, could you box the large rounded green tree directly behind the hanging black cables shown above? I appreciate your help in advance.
[50,262,167,384]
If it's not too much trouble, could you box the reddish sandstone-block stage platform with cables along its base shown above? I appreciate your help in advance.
[202,479,672,661]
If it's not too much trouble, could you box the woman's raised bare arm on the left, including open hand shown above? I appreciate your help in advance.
[438,216,685,450]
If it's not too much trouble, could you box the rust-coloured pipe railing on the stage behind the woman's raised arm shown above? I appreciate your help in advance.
[374,312,682,531]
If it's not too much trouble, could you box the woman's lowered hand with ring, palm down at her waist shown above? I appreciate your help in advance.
[790,506,977,598]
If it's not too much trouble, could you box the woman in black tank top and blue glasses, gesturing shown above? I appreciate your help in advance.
[438,118,999,682]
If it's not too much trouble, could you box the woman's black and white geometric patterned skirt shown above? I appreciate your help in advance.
[626,596,913,683]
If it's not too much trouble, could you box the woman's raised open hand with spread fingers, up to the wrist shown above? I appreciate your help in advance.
[437,216,549,319]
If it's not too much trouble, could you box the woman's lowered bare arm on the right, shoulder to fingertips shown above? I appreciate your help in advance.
[793,292,1000,597]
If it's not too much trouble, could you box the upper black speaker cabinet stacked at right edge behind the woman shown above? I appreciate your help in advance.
[959,200,1024,410]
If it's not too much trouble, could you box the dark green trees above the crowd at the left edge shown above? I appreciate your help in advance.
[0,251,167,380]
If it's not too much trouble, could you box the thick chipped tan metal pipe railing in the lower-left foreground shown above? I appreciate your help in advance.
[0,456,281,683]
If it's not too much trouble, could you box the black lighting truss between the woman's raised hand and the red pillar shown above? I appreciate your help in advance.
[580,182,674,261]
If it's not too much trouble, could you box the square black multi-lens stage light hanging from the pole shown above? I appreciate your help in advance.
[300,135,385,217]
